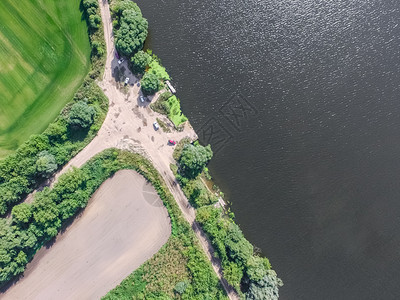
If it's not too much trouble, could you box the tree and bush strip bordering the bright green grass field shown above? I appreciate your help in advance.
[0,1,108,214]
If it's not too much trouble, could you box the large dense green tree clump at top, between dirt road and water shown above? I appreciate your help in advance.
[112,0,148,58]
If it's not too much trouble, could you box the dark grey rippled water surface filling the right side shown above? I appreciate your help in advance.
[137,0,400,299]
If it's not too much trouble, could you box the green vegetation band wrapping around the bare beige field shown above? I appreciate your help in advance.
[0,149,226,299]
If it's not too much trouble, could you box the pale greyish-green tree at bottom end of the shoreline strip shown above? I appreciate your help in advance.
[246,270,283,300]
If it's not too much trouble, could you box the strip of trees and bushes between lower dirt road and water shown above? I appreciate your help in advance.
[171,140,283,300]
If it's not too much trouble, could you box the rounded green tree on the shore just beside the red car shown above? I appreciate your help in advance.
[179,144,213,178]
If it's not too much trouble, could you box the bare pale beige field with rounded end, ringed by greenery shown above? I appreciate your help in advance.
[0,170,171,300]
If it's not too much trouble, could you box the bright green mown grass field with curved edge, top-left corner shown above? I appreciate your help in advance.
[0,0,90,158]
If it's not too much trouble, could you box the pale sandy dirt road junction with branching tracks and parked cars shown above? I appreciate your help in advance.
[11,0,238,299]
